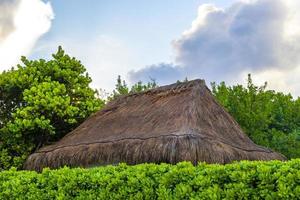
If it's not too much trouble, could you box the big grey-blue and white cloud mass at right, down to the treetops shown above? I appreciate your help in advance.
[130,0,300,96]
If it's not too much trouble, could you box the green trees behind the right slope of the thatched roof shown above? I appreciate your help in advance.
[212,75,300,158]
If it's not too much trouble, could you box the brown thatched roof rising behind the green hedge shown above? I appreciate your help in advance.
[25,80,285,170]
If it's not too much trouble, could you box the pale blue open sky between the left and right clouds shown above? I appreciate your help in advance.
[31,0,232,91]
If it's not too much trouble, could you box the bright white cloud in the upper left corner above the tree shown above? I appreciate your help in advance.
[0,0,54,70]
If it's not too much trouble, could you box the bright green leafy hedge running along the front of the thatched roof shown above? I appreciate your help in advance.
[0,159,300,200]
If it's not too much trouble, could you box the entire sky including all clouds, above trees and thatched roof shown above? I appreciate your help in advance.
[0,0,300,95]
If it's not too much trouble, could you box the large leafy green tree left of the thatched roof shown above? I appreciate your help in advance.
[0,47,104,168]
